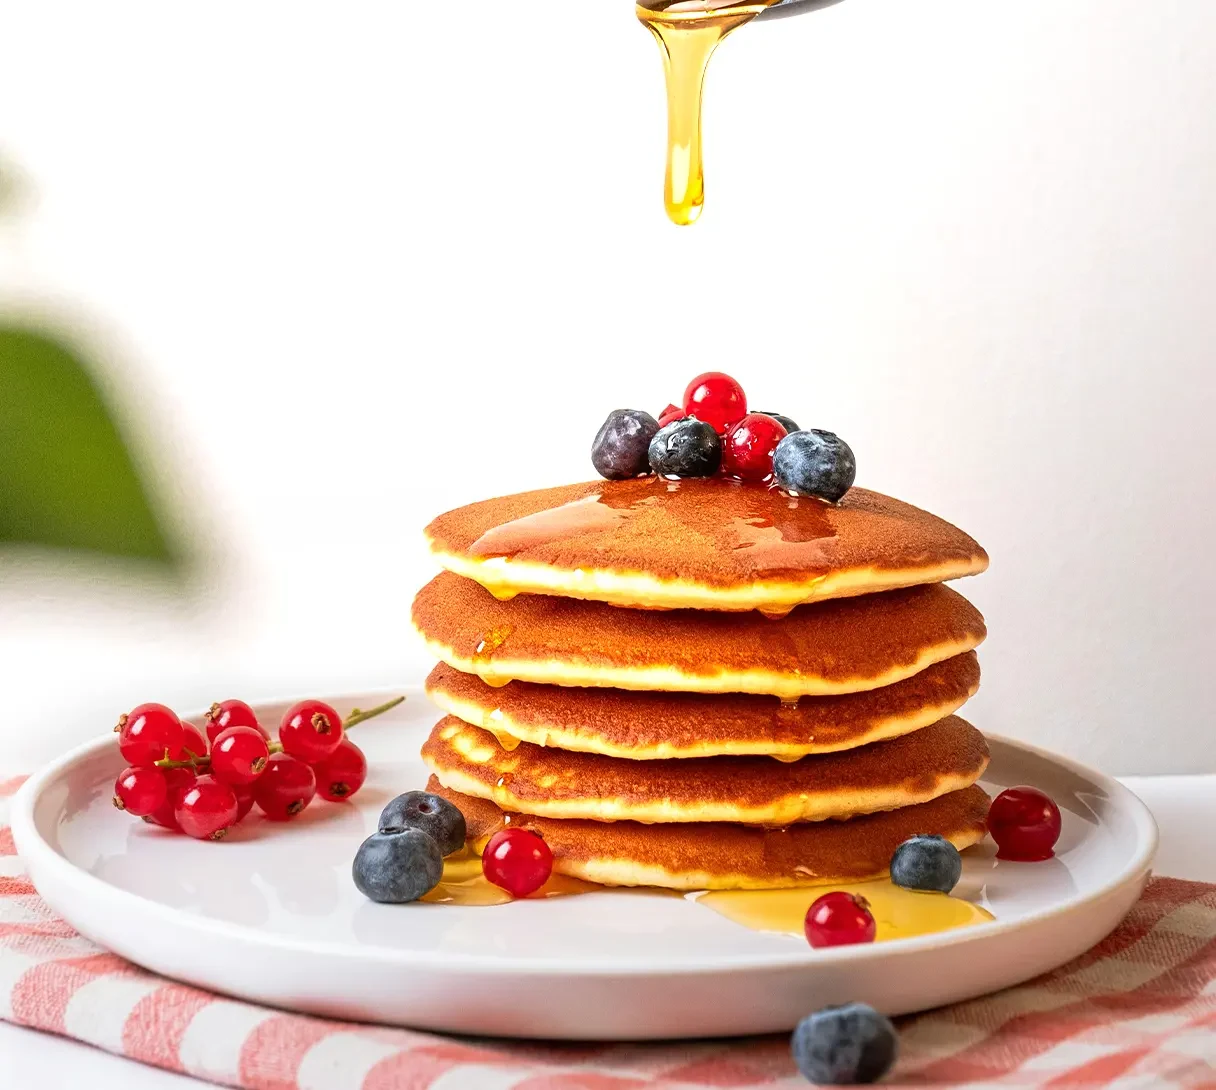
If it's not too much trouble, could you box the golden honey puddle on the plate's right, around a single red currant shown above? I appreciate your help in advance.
[691,878,992,943]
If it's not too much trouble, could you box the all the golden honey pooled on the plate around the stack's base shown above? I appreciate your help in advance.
[422,844,992,943]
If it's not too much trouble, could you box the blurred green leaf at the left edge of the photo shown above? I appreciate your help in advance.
[0,326,176,564]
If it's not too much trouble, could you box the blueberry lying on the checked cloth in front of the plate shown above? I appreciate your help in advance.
[789,1002,900,1086]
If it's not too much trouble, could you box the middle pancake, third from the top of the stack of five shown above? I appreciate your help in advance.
[427,651,980,760]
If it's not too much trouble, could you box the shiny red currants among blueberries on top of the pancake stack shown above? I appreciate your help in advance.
[659,371,789,481]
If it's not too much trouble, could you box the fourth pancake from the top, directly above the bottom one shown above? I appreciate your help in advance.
[422,715,989,827]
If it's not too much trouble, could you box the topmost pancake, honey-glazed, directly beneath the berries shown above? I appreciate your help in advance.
[426,477,987,614]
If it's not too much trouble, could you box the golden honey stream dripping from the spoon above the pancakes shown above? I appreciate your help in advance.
[637,0,778,226]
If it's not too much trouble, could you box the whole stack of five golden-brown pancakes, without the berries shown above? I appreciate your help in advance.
[413,478,989,889]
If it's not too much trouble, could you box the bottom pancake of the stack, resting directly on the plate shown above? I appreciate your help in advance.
[427,776,989,889]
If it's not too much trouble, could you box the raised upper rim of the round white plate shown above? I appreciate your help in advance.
[9,684,1160,979]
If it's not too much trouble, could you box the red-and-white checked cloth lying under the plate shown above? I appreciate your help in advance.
[0,780,1216,1090]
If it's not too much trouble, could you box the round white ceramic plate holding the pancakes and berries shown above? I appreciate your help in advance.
[12,690,1156,1040]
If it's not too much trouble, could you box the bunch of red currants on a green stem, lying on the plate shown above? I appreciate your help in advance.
[114,697,404,841]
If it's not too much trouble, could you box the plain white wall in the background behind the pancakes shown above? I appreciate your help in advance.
[0,0,1216,772]
